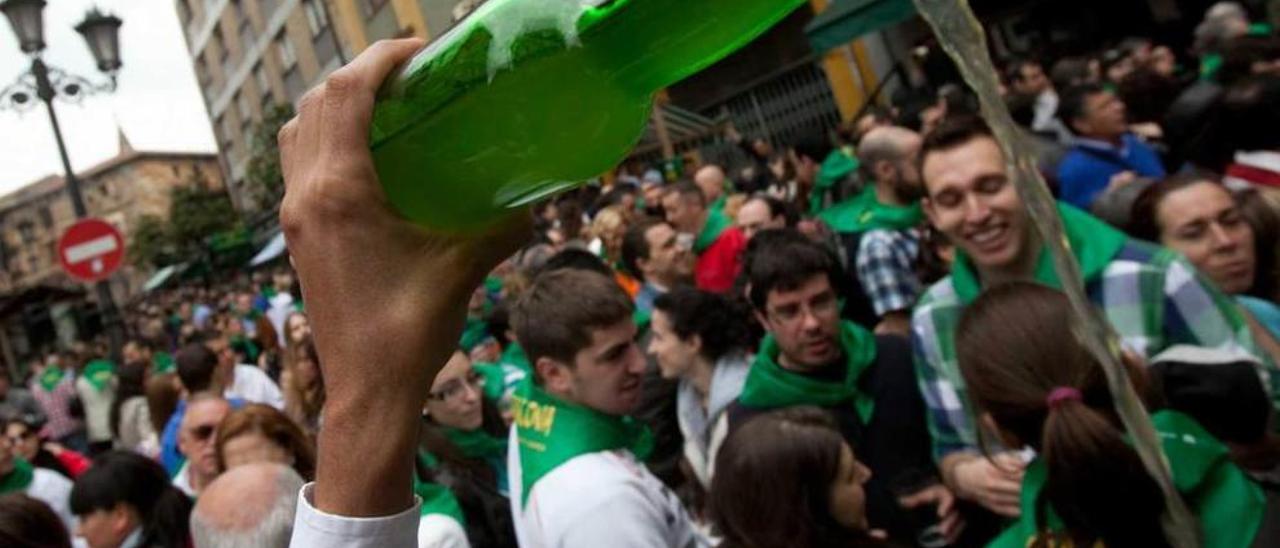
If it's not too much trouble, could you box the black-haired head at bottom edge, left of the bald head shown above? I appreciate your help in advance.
[70,451,192,548]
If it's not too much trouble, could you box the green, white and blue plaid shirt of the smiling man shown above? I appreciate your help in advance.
[911,241,1280,461]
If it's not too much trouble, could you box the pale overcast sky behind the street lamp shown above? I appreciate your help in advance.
[0,0,218,195]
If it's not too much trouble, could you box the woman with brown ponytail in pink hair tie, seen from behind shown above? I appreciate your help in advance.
[956,283,1266,548]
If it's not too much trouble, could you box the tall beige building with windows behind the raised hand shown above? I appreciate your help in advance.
[174,0,479,210]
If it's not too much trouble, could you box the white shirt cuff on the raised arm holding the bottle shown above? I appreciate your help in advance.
[289,483,422,548]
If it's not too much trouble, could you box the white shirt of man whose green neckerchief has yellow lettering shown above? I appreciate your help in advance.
[507,429,701,548]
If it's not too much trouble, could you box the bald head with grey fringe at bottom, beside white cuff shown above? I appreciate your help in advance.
[191,462,303,548]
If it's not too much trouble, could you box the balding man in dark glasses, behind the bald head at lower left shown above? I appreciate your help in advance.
[173,393,232,498]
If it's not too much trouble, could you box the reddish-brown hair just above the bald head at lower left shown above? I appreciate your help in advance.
[214,403,316,481]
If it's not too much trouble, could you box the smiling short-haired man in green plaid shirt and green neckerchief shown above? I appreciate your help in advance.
[911,120,1277,516]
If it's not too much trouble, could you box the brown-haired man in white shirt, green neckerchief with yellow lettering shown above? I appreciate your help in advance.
[507,269,696,547]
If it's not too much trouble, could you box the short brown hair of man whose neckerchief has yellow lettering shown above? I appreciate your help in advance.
[511,269,632,365]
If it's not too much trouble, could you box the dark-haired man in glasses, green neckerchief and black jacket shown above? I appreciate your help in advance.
[712,229,963,543]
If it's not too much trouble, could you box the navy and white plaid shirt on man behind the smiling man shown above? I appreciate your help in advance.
[854,228,920,316]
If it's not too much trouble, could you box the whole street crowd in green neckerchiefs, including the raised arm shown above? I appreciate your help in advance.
[0,3,1280,548]
